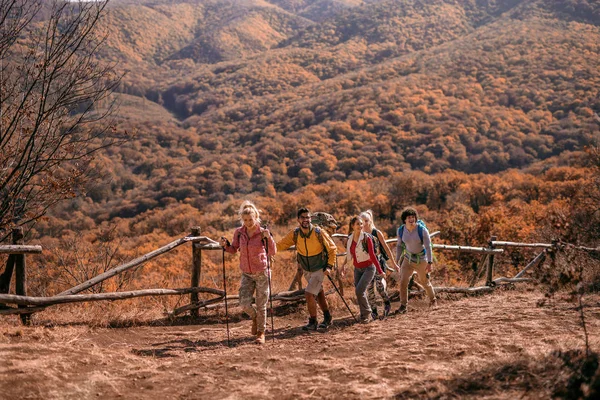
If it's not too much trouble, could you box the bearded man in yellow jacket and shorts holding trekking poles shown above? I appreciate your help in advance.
[277,208,337,331]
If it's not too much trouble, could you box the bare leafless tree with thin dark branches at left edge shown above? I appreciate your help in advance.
[0,0,122,234]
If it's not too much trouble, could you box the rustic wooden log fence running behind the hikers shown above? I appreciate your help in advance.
[0,227,598,324]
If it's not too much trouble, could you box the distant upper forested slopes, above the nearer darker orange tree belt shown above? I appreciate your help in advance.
[88,0,600,200]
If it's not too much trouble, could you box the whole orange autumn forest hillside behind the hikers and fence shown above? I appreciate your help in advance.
[24,0,600,290]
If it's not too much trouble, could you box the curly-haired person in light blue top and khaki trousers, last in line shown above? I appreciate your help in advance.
[396,207,437,314]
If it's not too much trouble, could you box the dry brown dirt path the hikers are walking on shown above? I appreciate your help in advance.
[0,291,600,399]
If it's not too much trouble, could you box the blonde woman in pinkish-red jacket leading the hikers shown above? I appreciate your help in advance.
[221,201,277,344]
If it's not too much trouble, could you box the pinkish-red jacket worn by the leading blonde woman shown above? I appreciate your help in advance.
[225,226,277,274]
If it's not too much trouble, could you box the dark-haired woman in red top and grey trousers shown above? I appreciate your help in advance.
[346,216,385,324]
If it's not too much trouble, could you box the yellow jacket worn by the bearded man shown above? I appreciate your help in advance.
[277,224,337,272]
